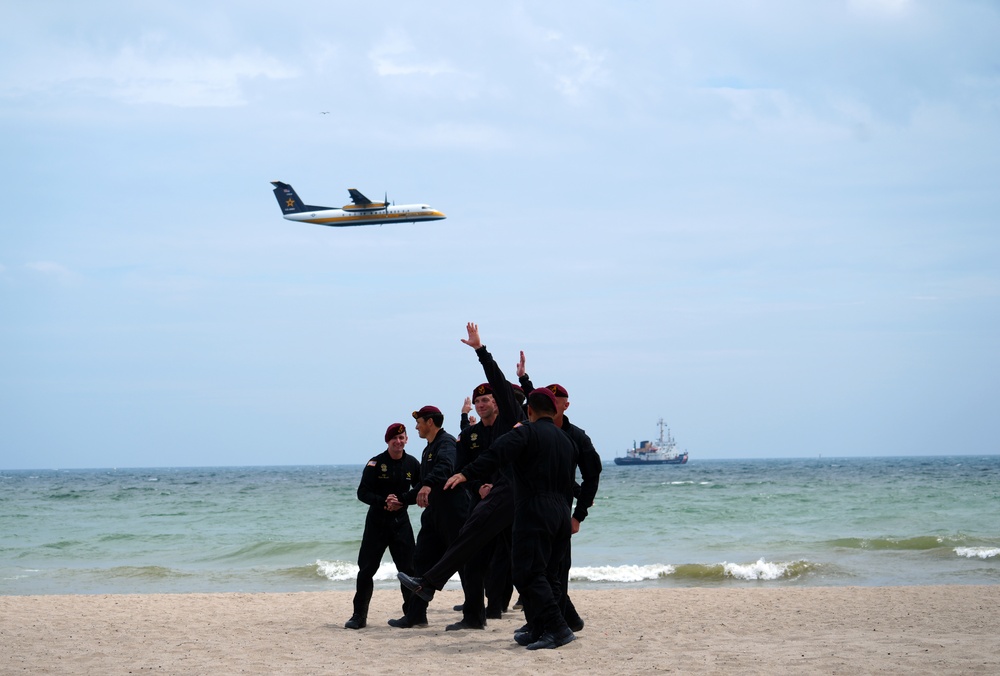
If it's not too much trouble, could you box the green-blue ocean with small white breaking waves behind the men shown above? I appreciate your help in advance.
[0,456,1000,595]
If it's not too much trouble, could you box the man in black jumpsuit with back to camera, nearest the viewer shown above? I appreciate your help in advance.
[445,389,578,650]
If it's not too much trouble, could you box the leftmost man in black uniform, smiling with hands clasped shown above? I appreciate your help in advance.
[344,423,420,629]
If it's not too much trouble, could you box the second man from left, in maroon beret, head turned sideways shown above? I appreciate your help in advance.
[389,406,469,629]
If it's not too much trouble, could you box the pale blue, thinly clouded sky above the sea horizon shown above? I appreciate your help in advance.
[0,0,1000,469]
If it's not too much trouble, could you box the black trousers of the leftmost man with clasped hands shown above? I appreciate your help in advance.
[354,509,415,619]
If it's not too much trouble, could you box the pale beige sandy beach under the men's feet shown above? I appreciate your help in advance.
[0,586,1000,676]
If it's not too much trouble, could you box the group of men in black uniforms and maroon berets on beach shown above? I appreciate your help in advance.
[345,323,601,650]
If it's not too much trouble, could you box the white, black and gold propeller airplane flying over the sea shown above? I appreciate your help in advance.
[271,181,446,228]
